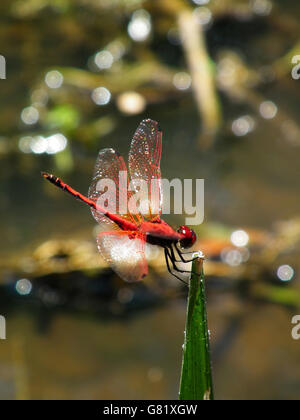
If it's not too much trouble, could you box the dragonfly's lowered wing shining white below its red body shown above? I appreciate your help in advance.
[97,231,148,282]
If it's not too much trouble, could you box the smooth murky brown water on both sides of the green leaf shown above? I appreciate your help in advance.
[0,296,300,399]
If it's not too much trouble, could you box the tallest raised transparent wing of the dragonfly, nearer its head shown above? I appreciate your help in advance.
[129,119,162,221]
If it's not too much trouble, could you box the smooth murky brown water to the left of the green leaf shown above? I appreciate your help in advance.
[1,306,184,399]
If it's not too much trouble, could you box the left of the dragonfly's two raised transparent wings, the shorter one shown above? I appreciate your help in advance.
[88,149,141,230]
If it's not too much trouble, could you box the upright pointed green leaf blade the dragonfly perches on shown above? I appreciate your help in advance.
[179,257,214,400]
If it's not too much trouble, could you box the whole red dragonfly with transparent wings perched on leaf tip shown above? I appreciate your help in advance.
[42,119,196,282]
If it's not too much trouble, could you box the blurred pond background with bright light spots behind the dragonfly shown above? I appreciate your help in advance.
[0,0,300,399]
